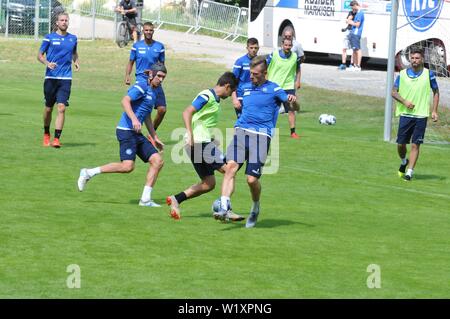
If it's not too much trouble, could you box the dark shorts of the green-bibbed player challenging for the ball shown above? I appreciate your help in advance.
[185,142,225,179]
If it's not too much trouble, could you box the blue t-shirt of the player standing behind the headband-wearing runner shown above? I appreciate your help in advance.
[130,40,165,83]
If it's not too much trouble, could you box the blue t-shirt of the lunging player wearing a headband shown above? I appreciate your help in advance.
[117,83,156,130]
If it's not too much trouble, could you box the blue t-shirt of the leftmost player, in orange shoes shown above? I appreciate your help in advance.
[39,32,77,80]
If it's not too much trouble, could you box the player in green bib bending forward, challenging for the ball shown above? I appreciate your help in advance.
[166,72,244,221]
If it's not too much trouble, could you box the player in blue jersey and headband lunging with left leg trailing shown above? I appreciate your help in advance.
[78,64,167,207]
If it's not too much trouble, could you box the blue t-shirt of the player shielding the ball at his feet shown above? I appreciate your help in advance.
[234,81,287,137]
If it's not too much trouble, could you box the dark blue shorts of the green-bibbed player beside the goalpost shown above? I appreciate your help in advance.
[397,116,428,144]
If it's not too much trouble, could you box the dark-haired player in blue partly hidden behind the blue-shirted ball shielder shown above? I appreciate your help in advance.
[231,38,259,117]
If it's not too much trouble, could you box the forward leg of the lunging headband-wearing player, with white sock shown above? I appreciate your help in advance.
[136,134,164,207]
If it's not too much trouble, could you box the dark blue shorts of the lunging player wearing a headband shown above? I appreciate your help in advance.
[116,129,158,163]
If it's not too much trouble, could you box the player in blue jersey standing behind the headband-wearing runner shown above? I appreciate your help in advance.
[125,22,167,130]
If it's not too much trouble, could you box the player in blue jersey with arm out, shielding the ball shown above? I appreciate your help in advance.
[214,56,296,228]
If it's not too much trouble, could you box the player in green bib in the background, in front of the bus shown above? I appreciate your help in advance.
[267,38,302,139]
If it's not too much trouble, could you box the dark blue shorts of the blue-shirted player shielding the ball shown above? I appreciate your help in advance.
[226,128,270,178]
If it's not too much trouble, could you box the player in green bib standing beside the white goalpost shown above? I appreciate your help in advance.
[392,48,439,181]
